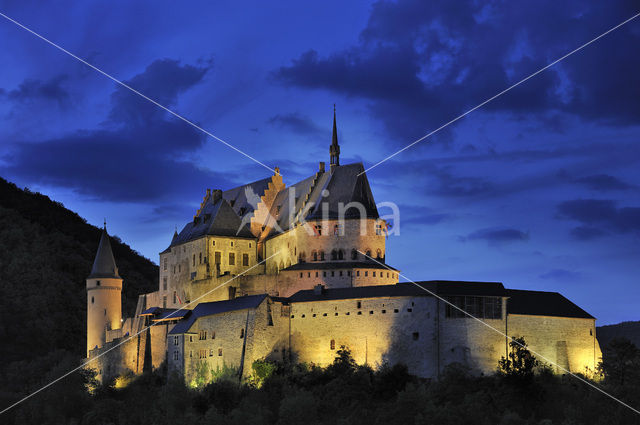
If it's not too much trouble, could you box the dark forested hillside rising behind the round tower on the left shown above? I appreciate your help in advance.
[0,178,158,405]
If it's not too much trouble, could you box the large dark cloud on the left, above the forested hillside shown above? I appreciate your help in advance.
[5,59,231,202]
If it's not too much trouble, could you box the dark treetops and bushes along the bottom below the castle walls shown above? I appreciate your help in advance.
[2,343,640,425]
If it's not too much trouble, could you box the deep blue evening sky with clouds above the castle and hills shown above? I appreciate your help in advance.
[0,0,640,324]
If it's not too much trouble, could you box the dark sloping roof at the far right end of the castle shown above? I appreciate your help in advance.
[507,289,595,319]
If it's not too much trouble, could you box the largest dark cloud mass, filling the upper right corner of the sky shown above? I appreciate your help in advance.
[272,0,640,142]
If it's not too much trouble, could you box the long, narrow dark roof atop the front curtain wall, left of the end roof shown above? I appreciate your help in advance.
[289,281,506,303]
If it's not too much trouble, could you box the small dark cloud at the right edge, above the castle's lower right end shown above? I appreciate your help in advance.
[557,199,640,235]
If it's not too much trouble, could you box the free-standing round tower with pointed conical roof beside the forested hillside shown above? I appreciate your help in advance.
[87,223,122,357]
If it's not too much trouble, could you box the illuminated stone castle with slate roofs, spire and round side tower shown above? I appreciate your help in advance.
[87,111,601,383]
